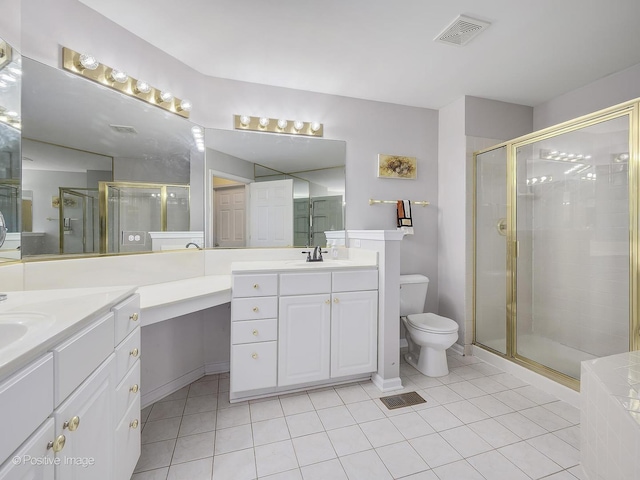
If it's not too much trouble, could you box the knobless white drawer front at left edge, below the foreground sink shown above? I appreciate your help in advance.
[0,353,53,463]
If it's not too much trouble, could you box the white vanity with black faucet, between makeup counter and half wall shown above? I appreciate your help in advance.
[230,261,378,402]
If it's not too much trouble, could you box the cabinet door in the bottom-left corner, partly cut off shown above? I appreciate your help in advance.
[0,418,54,480]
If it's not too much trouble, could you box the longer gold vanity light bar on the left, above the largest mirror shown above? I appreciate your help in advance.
[62,47,191,118]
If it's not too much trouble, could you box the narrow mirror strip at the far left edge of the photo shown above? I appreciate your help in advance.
[0,38,22,262]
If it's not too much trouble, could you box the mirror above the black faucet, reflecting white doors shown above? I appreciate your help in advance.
[205,129,346,248]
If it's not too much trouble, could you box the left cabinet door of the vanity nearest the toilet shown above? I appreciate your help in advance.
[278,294,331,386]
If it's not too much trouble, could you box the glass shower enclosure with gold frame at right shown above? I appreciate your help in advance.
[474,101,640,389]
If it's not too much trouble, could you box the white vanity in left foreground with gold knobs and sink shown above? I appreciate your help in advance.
[0,287,141,480]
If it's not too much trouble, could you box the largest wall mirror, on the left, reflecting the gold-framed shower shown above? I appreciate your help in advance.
[21,58,204,258]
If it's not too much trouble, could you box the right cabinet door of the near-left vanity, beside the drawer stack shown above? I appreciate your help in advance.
[53,354,116,480]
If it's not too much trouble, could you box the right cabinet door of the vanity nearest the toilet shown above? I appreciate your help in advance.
[331,291,378,378]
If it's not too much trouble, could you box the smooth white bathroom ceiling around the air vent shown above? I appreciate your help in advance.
[80,0,640,109]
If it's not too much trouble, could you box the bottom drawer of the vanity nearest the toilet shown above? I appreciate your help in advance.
[231,342,278,392]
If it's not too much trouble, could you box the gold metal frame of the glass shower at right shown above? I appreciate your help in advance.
[472,98,640,390]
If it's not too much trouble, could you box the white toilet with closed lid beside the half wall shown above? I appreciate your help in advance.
[400,275,458,377]
